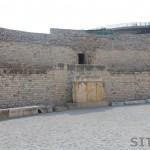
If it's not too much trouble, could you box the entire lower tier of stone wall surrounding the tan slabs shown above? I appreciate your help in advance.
[0,64,150,108]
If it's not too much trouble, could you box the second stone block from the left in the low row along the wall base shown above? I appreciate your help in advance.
[9,107,24,118]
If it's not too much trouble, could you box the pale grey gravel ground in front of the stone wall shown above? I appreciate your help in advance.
[0,105,150,150]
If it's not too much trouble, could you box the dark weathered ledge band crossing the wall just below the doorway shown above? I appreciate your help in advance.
[0,64,150,74]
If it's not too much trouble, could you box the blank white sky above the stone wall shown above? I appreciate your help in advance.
[0,0,150,33]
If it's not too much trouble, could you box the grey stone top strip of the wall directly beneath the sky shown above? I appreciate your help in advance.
[0,28,150,44]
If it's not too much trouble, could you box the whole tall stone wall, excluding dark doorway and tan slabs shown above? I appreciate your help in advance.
[0,28,150,108]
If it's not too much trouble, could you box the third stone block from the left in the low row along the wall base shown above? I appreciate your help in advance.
[23,106,39,116]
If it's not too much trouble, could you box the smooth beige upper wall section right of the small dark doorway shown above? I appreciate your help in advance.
[94,49,150,70]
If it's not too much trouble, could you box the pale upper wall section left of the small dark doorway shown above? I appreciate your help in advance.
[0,41,77,66]
